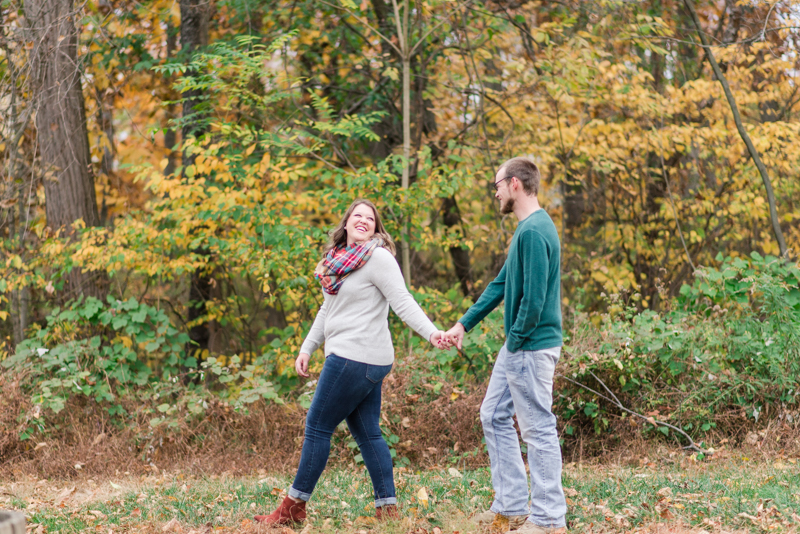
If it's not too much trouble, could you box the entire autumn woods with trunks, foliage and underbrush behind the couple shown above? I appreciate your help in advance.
[0,0,800,474]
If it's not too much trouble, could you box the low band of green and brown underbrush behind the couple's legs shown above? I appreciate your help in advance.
[0,254,800,476]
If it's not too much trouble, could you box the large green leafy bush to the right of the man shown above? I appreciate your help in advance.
[559,253,800,435]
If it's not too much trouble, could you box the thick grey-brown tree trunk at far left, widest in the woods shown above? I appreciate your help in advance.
[25,0,108,299]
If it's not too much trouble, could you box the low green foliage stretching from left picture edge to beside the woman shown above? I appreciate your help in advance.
[2,296,281,439]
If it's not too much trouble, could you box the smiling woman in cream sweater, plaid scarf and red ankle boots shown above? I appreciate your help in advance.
[255,199,444,525]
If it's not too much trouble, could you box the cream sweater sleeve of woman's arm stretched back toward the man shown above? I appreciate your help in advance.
[369,248,439,341]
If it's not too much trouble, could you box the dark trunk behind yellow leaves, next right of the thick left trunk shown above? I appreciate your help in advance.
[180,0,212,361]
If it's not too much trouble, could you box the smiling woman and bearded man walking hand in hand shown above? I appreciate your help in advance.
[255,158,566,534]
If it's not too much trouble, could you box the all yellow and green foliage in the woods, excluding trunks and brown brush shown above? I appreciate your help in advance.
[6,0,800,458]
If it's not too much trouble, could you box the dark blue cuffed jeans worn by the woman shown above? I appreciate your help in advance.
[289,354,397,507]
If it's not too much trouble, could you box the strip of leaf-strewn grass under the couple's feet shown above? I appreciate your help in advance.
[6,456,800,534]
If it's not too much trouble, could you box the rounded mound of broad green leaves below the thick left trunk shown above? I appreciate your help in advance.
[2,296,188,415]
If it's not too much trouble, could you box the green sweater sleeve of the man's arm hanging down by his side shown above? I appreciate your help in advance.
[506,231,549,352]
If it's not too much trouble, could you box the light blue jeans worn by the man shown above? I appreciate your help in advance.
[481,345,567,528]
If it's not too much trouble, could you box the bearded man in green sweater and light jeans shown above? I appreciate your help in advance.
[446,158,567,534]
